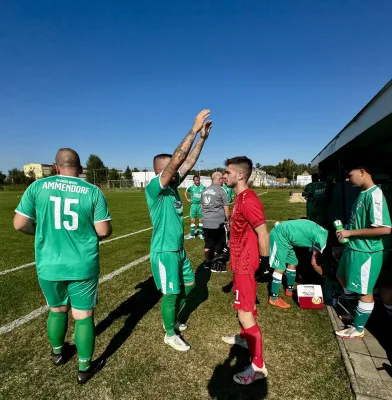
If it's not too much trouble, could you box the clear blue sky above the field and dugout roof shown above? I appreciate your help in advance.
[0,0,392,172]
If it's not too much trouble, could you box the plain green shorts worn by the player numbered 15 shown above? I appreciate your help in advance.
[38,276,99,311]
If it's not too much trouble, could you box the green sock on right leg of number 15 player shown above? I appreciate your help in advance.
[75,316,95,371]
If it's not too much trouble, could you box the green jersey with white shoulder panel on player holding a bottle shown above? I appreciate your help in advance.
[346,186,391,253]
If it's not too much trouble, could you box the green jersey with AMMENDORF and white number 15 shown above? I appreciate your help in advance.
[15,175,111,281]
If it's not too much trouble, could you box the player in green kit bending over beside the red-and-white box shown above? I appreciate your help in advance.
[268,219,328,308]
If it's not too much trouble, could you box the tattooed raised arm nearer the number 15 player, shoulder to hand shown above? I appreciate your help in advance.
[160,110,210,187]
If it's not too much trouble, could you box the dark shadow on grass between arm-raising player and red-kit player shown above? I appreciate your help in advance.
[178,262,211,323]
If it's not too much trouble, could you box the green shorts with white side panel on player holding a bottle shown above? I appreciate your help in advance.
[337,247,383,294]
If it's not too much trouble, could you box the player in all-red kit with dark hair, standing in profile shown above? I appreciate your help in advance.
[222,157,269,385]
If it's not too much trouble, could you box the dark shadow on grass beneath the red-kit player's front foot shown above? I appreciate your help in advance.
[208,345,268,400]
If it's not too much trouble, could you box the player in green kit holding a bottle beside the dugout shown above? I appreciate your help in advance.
[335,165,391,339]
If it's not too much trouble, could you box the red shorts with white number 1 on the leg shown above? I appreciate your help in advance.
[233,274,257,312]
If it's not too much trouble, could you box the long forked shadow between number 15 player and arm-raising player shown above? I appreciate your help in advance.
[96,277,161,359]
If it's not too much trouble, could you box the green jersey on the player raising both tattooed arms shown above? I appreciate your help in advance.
[145,173,184,253]
